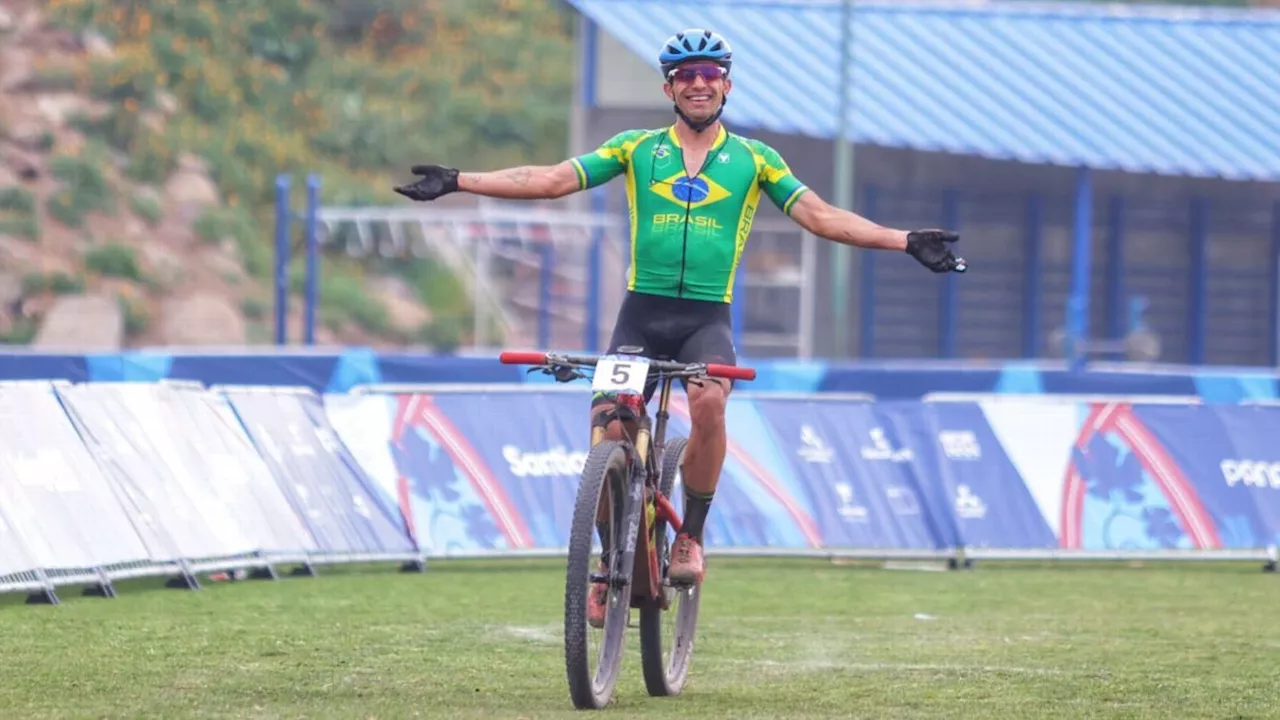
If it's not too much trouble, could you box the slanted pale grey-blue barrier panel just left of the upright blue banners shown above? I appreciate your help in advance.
[223,388,415,555]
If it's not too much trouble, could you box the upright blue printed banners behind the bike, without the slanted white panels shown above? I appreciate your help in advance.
[325,386,1280,560]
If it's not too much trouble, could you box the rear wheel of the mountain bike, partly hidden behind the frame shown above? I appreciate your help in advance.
[640,438,701,696]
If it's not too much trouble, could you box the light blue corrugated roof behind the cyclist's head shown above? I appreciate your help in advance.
[568,0,1280,181]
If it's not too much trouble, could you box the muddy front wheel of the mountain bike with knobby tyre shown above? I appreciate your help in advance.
[564,439,640,710]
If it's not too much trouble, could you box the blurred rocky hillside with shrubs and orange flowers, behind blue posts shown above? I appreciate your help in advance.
[0,0,572,348]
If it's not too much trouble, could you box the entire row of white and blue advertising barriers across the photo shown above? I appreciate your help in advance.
[0,380,1280,602]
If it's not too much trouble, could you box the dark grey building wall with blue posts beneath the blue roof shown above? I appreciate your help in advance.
[581,24,1280,365]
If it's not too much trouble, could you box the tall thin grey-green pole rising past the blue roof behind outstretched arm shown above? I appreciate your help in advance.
[831,0,856,357]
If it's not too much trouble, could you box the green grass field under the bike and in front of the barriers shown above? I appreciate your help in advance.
[0,557,1280,720]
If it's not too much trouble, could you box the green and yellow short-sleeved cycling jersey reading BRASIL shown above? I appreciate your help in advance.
[571,127,808,302]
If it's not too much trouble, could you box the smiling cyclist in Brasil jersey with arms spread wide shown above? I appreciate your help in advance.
[396,29,965,626]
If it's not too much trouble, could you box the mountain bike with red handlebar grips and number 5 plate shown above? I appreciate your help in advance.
[500,347,755,710]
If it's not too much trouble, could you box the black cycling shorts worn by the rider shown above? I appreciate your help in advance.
[593,292,737,405]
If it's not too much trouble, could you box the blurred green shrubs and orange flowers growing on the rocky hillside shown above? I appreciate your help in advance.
[20,0,575,345]
